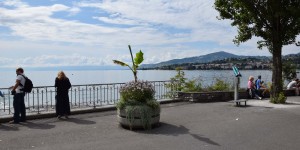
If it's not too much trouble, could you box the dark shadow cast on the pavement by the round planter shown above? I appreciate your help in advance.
[137,122,220,146]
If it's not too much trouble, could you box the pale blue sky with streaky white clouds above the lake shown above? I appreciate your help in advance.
[0,0,300,68]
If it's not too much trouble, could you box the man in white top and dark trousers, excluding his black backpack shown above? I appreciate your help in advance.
[10,68,26,123]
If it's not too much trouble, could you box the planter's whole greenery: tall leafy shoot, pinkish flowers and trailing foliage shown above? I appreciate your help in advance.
[113,45,160,129]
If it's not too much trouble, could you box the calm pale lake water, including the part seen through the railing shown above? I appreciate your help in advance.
[0,70,299,116]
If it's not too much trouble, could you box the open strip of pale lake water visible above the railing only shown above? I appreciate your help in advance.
[0,70,288,88]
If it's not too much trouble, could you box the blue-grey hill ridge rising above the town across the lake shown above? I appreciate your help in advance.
[140,51,269,68]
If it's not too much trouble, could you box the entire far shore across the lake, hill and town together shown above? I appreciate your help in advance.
[141,51,300,70]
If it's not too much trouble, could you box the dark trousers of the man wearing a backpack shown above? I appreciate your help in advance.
[13,93,26,123]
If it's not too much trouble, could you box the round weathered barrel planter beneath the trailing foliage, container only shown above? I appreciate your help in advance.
[117,106,160,129]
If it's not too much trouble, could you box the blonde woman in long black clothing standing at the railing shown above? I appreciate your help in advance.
[55,71,71,119]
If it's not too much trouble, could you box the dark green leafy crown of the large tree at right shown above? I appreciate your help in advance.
[215,0,300,53]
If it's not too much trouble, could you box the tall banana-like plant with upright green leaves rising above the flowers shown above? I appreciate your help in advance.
[113,45,144,82]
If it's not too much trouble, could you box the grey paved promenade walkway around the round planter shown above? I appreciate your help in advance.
[0,97,300,150]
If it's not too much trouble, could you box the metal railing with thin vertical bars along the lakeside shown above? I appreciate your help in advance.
[0,81,174,118]
